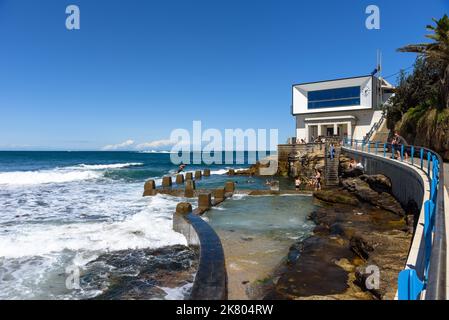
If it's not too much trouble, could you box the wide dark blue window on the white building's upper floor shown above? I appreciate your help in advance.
[308,87,360,109]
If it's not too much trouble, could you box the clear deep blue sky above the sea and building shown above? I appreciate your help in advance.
[0,0,449,150]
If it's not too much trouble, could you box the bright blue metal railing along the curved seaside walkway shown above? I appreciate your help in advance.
[343,139,446,300]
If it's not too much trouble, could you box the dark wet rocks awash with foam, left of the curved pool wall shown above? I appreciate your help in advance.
[80,245,199,300]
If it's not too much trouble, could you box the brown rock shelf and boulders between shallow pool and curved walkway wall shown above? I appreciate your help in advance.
[248,152,412,300]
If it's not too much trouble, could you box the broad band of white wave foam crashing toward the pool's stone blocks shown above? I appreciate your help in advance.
[0,196,186,258]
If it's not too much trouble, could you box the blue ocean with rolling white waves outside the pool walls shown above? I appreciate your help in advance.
[0,152,265,299]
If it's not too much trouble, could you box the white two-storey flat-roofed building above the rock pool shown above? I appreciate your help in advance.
[292,76,394,142]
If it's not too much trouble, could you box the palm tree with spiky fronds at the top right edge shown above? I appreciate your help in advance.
[398,14,449,108]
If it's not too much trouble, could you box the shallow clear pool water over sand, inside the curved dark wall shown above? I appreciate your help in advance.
[205,195,316,300]
